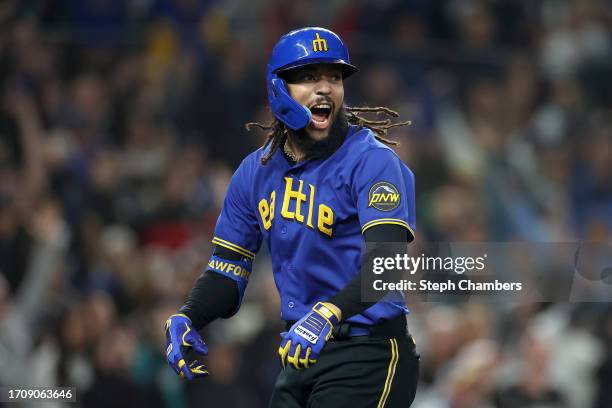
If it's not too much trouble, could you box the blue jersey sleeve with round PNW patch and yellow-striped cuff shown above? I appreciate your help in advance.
[352,148,416,239]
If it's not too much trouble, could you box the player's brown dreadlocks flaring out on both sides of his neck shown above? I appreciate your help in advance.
[245,106,411,165]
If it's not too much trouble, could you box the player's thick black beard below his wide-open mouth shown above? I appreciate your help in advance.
[289,107,348,160]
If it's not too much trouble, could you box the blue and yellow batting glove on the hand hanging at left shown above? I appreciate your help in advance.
[166,314,208,380]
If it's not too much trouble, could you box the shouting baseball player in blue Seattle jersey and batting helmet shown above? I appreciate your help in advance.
[166,27,418,408]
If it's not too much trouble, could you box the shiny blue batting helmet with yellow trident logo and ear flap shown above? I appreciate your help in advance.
[267,27,357,130]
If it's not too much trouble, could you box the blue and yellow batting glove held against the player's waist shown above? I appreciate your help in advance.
[278,302,341,369]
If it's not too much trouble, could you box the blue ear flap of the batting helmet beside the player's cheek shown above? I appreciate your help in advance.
[268,74,312,130]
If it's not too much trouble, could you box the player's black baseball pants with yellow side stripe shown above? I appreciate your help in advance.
[270,335,419,408]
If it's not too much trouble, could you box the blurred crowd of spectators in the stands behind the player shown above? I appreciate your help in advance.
[0,0,612,408]
